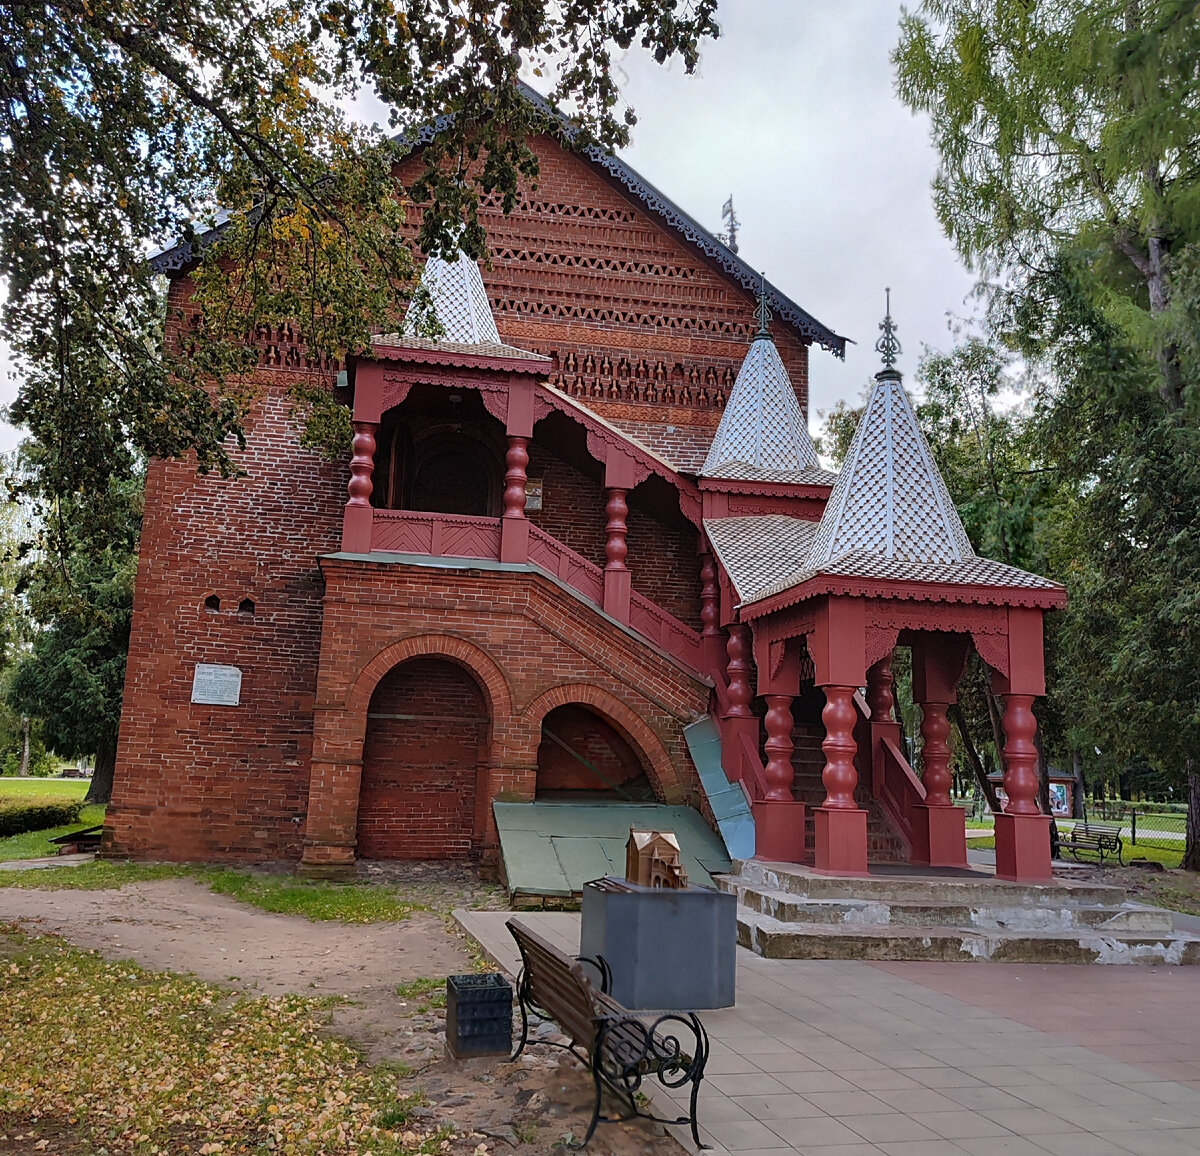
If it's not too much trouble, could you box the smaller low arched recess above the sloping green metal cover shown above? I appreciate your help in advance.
[536,702,654,803]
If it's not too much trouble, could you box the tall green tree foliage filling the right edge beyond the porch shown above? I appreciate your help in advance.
[895,0,1200,869]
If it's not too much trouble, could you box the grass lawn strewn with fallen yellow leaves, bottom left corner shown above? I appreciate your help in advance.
[0,926,445,1156]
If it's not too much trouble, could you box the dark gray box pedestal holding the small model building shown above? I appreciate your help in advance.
[580,876,738,1011]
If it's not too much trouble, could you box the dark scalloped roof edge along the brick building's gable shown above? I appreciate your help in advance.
[150,83,846,358]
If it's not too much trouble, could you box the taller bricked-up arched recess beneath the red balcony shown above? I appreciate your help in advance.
[358,658,491,859]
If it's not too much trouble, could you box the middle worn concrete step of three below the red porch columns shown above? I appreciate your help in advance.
[716,875,1175,935]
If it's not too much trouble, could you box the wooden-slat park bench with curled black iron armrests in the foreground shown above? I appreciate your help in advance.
[508,920,708,1148]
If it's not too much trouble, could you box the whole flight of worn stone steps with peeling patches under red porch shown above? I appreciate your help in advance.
[716,859,1200,964]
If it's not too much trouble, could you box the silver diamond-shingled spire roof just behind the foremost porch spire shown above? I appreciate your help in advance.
[701,335,821,481]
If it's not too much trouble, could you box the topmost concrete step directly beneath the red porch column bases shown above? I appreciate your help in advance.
[728,859,1126,908]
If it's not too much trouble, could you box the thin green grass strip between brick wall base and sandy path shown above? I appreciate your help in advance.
[0,859,428,923]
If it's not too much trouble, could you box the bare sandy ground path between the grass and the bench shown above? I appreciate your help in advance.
[0,879,683,1156]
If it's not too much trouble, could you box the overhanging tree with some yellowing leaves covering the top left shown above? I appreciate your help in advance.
[0,0,718,542]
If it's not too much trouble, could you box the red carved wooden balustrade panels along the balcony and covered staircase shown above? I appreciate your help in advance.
[371,509,701,671]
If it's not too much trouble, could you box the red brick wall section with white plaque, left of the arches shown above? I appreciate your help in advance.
[108,375,344,859]
